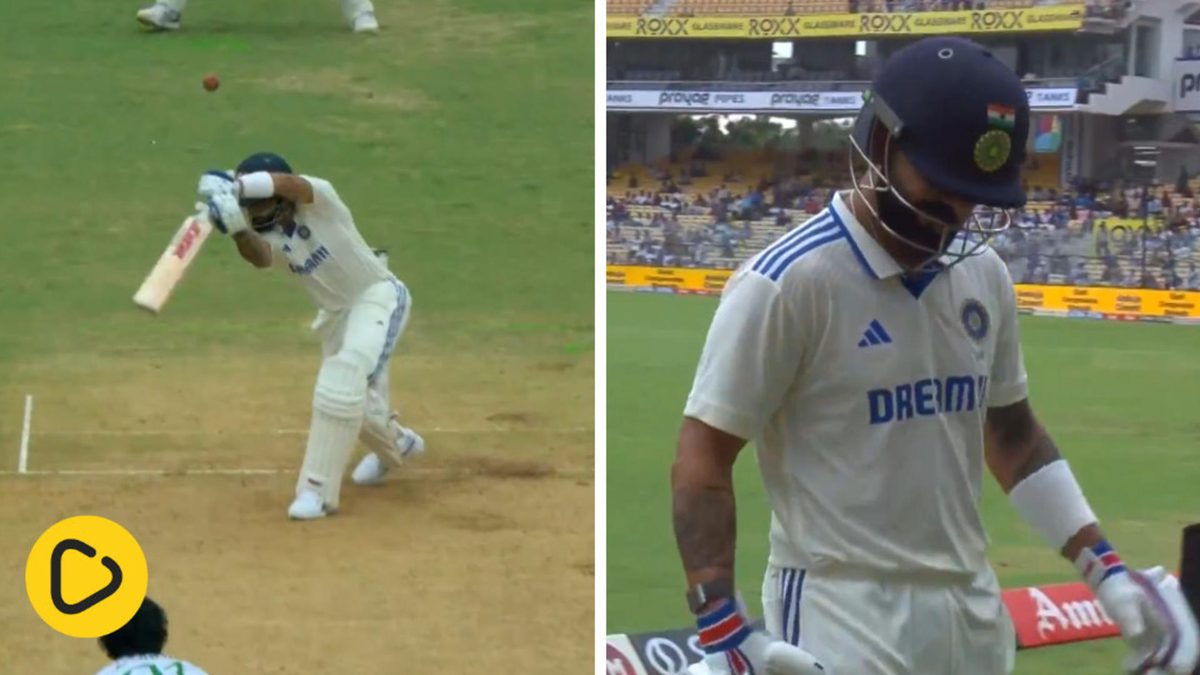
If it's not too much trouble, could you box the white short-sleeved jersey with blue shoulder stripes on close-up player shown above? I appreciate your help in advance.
[685,195,1026,575]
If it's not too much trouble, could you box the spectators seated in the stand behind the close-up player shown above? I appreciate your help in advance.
[607,162,1200,289]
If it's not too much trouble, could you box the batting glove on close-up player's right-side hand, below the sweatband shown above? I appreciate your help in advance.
[1075,540,1200,675]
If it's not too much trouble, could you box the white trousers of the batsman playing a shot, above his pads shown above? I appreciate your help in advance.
[312,277,413,435]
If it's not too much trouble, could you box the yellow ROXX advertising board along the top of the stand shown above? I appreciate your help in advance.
[605,4,1084,40]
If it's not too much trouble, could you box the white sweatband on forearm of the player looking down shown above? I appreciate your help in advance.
[1008,459,1096,550]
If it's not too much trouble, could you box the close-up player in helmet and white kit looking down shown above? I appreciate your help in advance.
[671,37,1200,675]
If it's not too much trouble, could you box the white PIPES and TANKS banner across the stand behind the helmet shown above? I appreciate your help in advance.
[607,88,1076,113]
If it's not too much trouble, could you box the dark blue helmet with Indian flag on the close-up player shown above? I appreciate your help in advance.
[850,37,1030,264]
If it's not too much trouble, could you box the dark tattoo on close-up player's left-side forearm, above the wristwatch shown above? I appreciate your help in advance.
[672,485,737,579]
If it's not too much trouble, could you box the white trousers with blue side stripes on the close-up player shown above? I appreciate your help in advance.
[762,566,1016,675]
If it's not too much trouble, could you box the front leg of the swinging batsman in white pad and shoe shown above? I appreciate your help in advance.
[288,350,367,520]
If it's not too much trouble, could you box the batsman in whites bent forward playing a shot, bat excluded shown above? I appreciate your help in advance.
[199,153,425,520]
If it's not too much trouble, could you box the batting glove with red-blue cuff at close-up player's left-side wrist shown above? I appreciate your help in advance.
[689,598,832,675]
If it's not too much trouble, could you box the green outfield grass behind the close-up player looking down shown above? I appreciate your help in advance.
[607,292,1200,675]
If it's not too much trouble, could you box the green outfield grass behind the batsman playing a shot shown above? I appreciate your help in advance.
[0,0,594,364]
